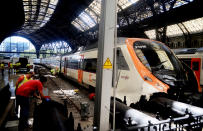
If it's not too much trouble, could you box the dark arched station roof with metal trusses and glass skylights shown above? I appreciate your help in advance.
[0,0,203,50]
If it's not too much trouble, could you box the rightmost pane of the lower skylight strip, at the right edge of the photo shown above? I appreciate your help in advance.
[183,17,203,33]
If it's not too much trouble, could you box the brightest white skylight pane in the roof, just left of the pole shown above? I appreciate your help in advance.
[79,12,96,28]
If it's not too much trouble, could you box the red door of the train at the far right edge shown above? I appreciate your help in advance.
[191,58,201,92]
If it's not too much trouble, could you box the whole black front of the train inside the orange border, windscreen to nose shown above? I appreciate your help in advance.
[133,40,196,92]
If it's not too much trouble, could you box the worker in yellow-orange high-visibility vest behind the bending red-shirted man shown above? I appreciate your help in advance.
[15,72,34,114]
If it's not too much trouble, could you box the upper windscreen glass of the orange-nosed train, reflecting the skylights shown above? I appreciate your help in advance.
[134,41,174,71]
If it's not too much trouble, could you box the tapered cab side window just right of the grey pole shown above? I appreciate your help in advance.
[116,48,129,70]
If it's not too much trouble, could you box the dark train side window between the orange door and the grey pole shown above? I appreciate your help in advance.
[83,58,97,73]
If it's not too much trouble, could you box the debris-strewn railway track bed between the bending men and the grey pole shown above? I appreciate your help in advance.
[35,66,94,130]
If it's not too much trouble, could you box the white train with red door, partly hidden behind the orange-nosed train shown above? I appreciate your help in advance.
[176,48,203,92]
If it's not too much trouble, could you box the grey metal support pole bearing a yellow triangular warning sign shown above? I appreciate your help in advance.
[94,0,117,131]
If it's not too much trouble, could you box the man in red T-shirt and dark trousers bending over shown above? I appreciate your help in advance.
[16,76,47,131]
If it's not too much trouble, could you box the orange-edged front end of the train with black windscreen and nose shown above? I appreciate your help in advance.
[126,38,199,100]
